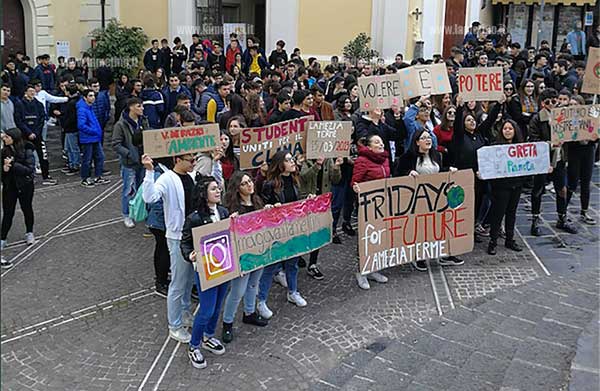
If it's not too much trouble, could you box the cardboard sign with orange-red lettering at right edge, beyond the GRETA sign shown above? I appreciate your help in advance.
[550,104,600,144]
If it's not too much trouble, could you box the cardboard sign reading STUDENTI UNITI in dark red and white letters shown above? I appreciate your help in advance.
[240,115,313,169]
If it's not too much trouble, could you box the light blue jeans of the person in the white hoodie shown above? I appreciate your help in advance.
[167,238,195,330]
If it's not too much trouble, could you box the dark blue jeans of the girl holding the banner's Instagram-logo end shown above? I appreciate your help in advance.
[190,273,229,348]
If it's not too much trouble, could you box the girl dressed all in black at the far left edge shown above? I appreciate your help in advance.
[0,128,35,268]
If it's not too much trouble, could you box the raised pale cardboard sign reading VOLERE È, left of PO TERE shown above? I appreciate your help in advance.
[358,64,452,111]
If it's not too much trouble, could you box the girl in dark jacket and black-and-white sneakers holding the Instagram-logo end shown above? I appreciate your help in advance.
[181,176,229,368]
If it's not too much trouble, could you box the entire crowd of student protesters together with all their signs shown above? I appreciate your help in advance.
[1,9,600,378]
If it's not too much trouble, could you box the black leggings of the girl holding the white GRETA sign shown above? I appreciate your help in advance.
[490,185,521,242]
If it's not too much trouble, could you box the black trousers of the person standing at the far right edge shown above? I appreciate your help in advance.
[567,143,596,210]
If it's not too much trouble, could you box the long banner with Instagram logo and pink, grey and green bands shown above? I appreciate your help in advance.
[192,193,333,291]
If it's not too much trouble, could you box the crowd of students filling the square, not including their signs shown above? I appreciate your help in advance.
[1,20,599,368]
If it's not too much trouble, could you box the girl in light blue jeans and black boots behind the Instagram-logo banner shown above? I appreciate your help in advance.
[223,171,273,343]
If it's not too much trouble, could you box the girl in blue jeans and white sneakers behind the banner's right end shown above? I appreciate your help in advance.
[257,150,307,319]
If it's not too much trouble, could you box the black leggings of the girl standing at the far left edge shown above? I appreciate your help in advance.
[1,182,33,240]
